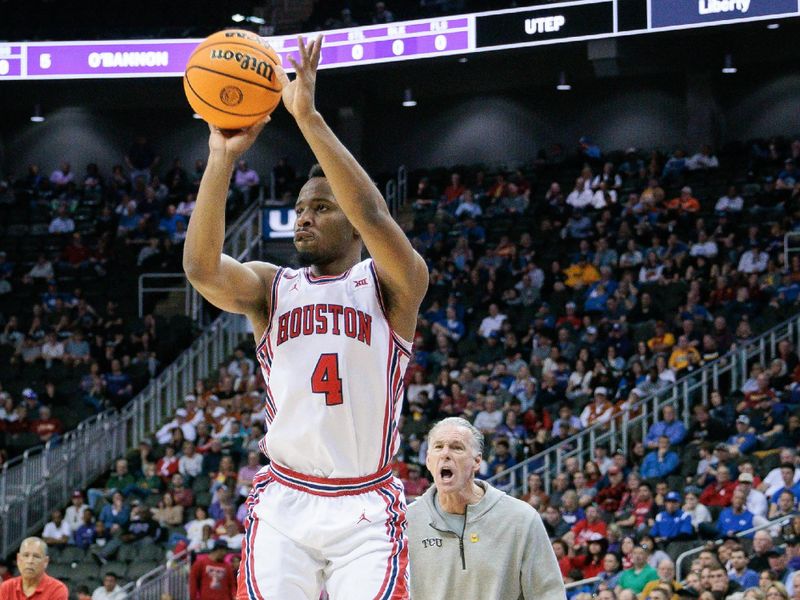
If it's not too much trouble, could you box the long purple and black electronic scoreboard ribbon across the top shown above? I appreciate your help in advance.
[0,0,800,82]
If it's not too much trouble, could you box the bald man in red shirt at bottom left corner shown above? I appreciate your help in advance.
[0,537,69,600]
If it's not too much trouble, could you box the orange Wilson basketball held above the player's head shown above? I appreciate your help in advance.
[183,29,282,129]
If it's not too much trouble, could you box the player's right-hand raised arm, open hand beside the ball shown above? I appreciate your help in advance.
[276,37,428,337]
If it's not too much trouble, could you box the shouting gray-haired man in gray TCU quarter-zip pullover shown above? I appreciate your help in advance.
[408,417,566,600]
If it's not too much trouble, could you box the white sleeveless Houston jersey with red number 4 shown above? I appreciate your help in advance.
[256,259,411,478]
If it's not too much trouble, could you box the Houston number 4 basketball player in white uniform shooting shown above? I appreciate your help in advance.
[184,38,428,600]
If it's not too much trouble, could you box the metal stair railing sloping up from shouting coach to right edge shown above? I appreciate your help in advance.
[489,315,800,494]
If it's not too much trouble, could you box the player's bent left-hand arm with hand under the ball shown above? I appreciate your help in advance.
[183,119,276,333]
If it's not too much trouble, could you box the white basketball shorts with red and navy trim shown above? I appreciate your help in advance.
[236,463,409,600]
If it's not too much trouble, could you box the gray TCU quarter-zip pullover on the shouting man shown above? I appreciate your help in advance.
[408,481,566,600]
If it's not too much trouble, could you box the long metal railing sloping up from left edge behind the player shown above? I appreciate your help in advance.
[0,202,261,557]
